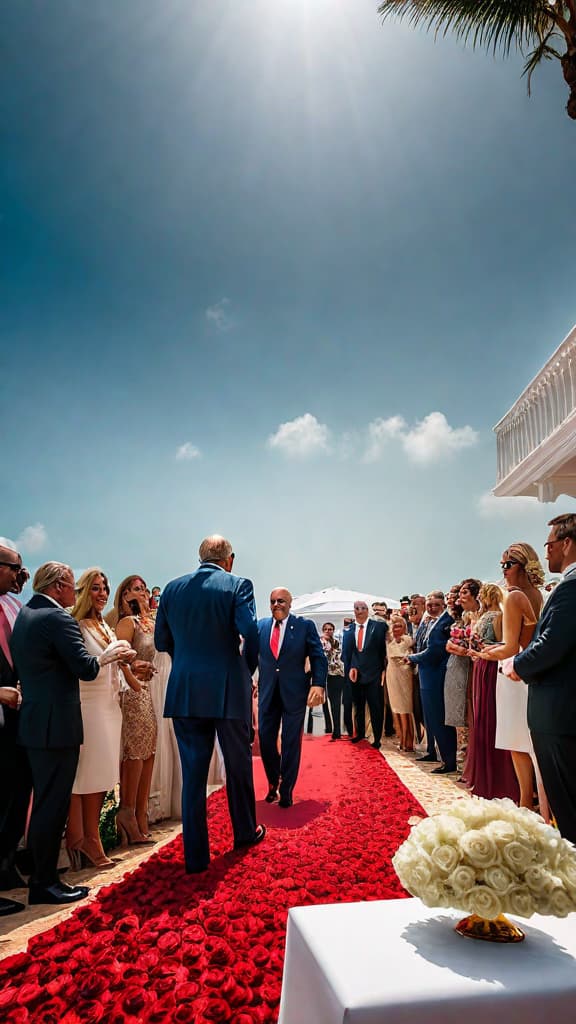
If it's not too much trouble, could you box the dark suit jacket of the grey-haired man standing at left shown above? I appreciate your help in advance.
[10,594,99,750]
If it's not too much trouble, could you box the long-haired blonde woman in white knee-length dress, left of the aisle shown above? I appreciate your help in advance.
[66,568,139,868]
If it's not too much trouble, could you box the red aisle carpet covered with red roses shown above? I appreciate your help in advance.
[0,737,424,1024]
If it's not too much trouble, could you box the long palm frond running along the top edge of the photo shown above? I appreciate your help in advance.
[378,0,554,55]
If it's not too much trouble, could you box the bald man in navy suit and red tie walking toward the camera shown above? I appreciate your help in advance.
[253,587,328,807]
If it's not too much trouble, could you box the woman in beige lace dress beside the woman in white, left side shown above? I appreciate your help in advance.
[114,575,158,846]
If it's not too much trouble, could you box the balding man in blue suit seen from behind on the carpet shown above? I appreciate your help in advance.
[155,536,265,873]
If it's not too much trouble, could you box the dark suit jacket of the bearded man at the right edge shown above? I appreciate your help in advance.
[513,573,576,736]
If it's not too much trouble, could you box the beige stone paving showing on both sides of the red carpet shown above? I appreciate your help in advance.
[0,741,465,958]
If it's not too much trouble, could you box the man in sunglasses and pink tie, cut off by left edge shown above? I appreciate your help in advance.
[0,545,32,916]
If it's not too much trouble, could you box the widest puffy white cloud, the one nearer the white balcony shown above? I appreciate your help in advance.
[365,412,478,465]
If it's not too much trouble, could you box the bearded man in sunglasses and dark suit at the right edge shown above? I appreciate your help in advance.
[503,514,576,844]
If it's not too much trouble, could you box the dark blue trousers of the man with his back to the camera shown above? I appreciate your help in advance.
[173,718,256,871]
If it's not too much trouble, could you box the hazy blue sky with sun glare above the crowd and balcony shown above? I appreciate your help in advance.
[0,0,576,610]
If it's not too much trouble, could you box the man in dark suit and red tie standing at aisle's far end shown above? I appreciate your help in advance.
[342,601,388,751]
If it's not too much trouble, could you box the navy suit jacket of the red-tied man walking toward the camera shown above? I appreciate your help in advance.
[253,614,328,713]
